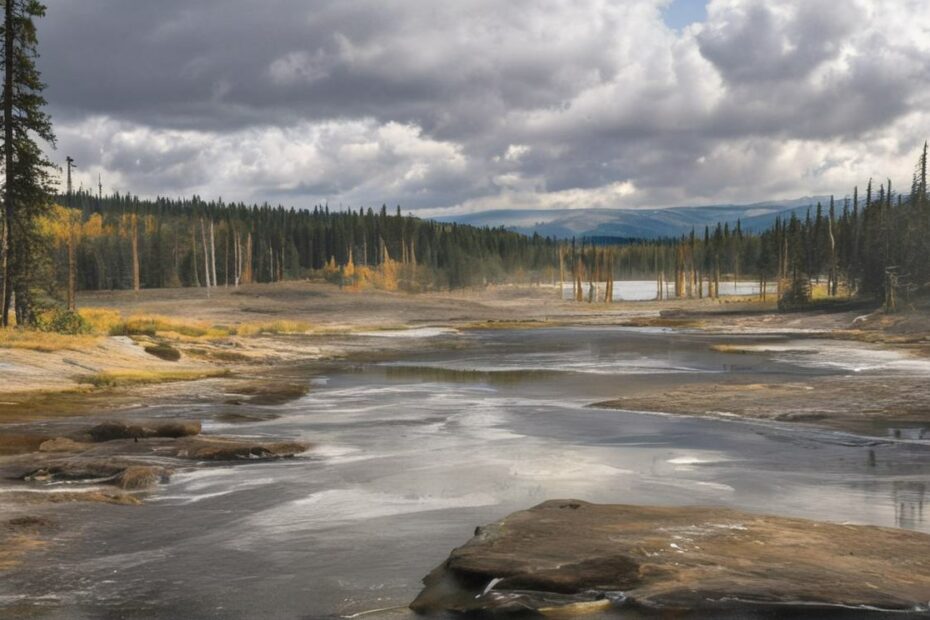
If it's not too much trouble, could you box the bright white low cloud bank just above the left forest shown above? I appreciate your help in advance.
[58,117,467,206]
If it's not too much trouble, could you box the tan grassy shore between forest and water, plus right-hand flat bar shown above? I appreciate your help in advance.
[0,282,930,436]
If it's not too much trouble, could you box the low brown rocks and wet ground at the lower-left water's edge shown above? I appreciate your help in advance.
[0,419,310,570]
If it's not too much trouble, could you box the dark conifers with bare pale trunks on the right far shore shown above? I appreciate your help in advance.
[624,143,930,310]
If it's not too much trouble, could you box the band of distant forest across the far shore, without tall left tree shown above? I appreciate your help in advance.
[41,140,930,309]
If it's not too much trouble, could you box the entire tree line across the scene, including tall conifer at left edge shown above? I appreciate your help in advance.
[0,0,930,326]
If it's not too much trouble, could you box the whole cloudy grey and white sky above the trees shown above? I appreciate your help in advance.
[40,0,930,214]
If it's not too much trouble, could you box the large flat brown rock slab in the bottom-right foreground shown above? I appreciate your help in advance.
[411,500,930,614]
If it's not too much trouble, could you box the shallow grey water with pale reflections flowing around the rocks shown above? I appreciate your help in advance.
[0,328,930,618]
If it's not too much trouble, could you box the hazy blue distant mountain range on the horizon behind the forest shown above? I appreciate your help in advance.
[433,196,830,239]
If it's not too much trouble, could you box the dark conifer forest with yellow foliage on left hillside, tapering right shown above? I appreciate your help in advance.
[50,191,557,290]
